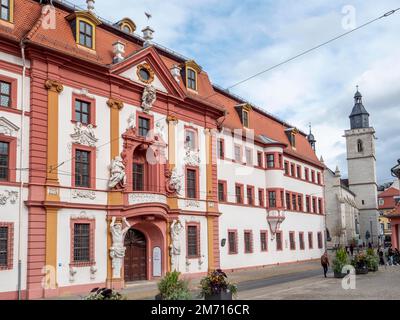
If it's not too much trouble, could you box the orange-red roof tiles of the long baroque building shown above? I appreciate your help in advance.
[0,0,323,167]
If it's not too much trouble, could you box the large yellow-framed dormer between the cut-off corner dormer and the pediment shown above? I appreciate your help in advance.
[66,11,101,51]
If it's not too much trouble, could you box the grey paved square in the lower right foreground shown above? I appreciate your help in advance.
[238,266,400,300]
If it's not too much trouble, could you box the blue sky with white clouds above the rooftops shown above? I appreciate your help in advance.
[73,0,400,183]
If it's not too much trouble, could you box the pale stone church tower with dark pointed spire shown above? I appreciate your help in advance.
[345,87,380,245]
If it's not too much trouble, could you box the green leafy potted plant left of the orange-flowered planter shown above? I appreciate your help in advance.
[155,271,191,300]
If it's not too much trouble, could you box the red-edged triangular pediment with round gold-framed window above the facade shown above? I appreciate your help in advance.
[111,46,185,98]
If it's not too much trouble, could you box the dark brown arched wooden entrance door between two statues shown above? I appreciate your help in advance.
[124,229,147,281]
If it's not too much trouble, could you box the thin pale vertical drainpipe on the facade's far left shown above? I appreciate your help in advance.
[18,41,26,300]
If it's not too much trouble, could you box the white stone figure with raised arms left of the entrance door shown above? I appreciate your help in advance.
[110,217,131,279]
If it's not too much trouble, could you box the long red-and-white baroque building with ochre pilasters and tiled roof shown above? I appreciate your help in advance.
[0,0,325,299]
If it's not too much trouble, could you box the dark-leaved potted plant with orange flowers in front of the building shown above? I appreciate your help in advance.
[200,269,237,300]
